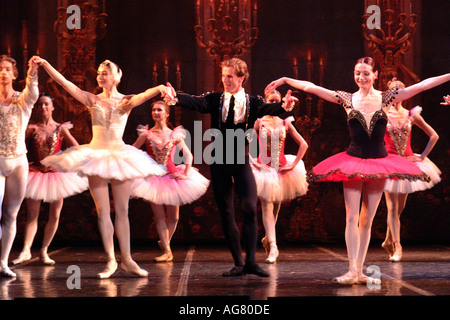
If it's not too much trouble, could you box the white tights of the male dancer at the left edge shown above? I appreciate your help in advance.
[0,155,28,267]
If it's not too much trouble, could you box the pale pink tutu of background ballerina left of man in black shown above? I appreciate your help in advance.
[131,165,209,206]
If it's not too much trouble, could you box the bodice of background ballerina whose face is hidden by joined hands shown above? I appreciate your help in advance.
[258,125,286,168]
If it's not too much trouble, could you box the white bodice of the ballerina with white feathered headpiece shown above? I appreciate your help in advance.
[90,104,128,149]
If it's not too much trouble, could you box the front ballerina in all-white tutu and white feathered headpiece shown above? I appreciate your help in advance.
[37,58,169,279]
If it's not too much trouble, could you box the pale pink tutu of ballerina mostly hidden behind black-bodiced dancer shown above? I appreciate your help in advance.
[384,154,441,193]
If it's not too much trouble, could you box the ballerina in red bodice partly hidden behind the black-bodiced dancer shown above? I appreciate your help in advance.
[381,78,441,262]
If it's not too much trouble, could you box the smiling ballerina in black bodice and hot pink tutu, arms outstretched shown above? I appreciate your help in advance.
[266,57,450,284]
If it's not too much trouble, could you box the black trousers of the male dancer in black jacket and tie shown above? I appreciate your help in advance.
[210,159,258,266]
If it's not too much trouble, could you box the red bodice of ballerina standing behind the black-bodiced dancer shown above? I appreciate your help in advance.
[384,118,413,157]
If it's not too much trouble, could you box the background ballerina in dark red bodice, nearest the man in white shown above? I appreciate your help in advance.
[12,94,89,265]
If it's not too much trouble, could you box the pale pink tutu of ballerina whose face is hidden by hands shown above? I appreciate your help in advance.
[252,154,308,202]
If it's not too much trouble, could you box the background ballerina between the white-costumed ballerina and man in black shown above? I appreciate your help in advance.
[131,101,209,262]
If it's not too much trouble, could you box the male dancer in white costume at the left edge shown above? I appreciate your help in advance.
[0,55,39,278]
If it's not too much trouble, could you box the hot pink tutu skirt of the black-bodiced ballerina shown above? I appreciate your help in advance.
[308,152,430,182]
